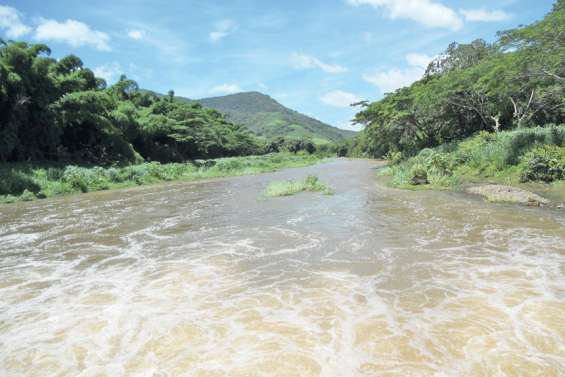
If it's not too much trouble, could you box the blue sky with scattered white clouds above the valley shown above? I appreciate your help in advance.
[0,0,553,130]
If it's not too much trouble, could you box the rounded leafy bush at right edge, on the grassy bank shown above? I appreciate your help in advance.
[520,145,565,182]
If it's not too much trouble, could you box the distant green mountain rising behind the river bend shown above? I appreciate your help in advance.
[185,92,355,142]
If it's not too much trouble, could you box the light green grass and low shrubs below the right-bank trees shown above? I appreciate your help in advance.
[379,125,565,199]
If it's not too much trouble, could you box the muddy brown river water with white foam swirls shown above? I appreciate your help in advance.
[0,160,565,377]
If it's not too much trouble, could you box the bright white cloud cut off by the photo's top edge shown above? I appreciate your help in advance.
[346,0,463,30]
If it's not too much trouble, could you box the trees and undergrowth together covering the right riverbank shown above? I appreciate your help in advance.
[350,0,565,187]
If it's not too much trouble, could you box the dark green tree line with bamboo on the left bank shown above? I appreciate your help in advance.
[0,40,326,165]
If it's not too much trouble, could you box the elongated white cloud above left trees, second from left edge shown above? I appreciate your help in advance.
[34,19,110,51]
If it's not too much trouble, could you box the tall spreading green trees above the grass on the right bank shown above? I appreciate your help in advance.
[349,5,565,159]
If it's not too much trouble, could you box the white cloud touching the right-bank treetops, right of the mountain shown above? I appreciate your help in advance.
[363,53,433,93]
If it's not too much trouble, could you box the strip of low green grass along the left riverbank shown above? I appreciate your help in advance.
[0,153,324,203]
